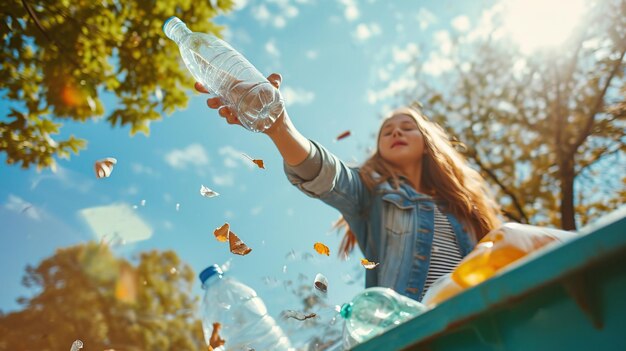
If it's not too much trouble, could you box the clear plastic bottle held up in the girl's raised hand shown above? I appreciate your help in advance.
[163,17,284,132]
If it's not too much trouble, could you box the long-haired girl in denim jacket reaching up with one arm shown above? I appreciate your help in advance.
[195,74,500,301]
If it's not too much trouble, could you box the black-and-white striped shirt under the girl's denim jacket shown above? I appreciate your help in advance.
[420,206,463,300]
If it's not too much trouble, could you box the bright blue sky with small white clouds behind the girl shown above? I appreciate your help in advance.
[0,0,588,346]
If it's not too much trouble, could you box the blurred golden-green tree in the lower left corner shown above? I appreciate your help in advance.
[0,242,206,351]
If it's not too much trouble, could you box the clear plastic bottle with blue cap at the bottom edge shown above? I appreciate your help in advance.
[200,265,294,351]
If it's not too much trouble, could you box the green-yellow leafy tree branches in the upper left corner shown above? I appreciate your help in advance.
[0,0,233,169]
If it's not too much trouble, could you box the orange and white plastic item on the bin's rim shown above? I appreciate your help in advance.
[452,223,577,288]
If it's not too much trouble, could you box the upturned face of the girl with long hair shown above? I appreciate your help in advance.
[378,114,424,168]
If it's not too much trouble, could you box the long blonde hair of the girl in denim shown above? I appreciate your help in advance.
[333,107,500,257]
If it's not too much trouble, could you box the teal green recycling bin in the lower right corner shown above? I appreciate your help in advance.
[354,206,626,351]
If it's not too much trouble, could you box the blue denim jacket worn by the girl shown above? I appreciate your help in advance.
[285,141,475,300]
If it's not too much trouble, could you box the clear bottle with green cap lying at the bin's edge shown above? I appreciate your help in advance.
[340,287,428,349]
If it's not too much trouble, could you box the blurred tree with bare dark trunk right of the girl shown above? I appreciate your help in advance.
[413,0,626,230]
